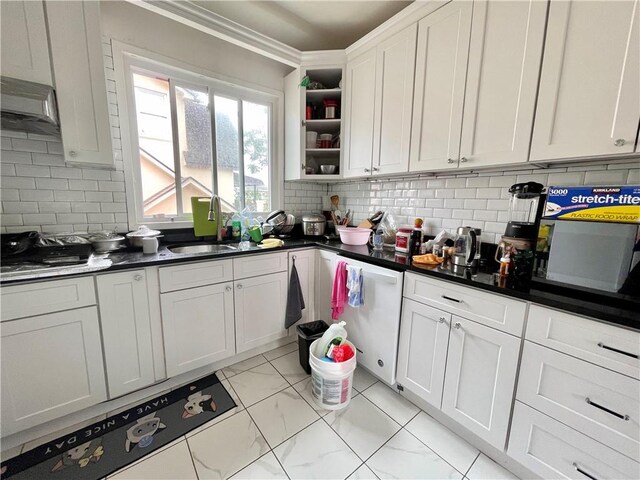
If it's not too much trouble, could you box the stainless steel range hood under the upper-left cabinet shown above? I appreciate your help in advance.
[0,77,60,135]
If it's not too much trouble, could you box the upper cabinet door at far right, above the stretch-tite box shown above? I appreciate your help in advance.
[531,0,640,161]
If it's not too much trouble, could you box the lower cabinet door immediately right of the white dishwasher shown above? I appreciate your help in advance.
[396,299,451,408]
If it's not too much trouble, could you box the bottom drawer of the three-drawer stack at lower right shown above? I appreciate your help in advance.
[507,402,640,480]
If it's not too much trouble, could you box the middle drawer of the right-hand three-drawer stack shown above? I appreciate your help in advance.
[517,342,640,461]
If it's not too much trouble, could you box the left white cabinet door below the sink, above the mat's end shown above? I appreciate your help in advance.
[160,283,235,377]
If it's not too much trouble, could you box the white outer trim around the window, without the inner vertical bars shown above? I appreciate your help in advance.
[111,40,284,230]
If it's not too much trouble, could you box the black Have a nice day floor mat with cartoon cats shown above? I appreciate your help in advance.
[0,374,236,480]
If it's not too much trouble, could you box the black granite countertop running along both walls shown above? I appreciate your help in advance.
[1,238,640,330]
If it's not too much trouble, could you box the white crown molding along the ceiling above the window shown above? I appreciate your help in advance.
[127,0,302,67]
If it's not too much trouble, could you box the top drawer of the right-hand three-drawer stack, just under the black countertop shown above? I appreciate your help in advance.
[526,305,640,379]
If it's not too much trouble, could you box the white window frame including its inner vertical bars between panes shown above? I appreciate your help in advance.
[112,40,284,229]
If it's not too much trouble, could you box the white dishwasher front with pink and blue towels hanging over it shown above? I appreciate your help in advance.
[336,256,404,385]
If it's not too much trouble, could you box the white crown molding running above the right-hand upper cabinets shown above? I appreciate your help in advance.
[345,0,451,58]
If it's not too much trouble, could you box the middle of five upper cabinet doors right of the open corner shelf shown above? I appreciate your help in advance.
[409,1,473,171]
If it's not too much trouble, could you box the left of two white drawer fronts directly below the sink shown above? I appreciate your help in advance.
[159,260,233,293]
